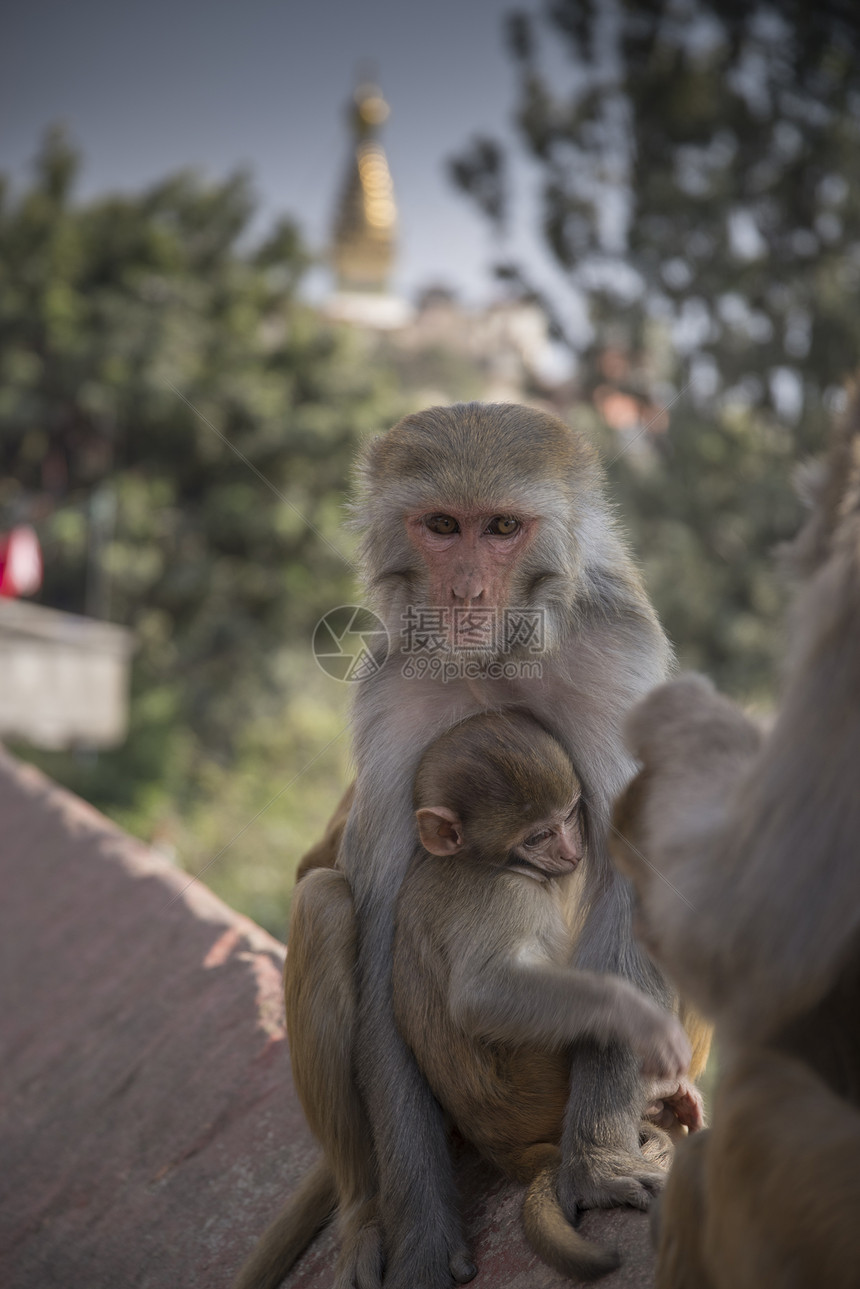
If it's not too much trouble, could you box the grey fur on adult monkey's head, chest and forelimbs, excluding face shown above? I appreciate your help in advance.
[339,403,670,1289]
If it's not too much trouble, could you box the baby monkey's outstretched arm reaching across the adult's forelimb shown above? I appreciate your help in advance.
[449,933,691,1079]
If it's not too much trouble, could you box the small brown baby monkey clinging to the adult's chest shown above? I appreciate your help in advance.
[393,710,701,1279]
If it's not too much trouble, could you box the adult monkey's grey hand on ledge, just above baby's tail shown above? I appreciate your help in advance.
[558,1143,665,1222]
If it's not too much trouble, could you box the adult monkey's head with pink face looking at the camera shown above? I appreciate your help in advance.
[352,403,603,661]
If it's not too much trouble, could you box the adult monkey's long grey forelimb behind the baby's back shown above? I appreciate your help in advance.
[340,742,476,1289]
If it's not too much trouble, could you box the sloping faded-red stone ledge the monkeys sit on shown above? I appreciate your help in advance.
[0,753,652,1289]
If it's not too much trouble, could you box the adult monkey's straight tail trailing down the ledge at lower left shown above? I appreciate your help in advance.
[232,1155,338,1289]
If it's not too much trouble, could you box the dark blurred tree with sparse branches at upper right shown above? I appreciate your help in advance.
[451,0,860,696]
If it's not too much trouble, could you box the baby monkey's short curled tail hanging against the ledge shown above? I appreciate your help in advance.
[522,1146,621,1280]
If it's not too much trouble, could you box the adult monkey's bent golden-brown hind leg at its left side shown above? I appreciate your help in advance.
[284,869,382,1289]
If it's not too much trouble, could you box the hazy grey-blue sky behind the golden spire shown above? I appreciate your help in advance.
[0,0,564,299]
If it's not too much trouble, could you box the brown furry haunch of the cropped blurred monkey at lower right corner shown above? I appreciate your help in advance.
[656,1048,860,1289]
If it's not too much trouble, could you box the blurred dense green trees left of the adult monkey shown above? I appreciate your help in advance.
[0,131,396,924]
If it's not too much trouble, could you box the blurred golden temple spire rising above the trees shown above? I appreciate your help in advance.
[331,82,397,295]
